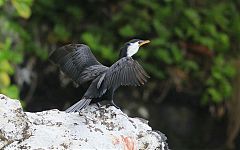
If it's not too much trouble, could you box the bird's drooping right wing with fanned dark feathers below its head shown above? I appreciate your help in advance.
[97,57,149,91]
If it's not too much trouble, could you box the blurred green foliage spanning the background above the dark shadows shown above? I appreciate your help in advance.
[0,0,240,103]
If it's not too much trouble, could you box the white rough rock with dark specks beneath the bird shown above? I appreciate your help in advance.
[0,94,168,150]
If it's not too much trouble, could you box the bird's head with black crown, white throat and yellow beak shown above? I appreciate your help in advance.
[120,39,150,58]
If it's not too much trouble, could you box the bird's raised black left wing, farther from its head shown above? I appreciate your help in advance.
[49,44,108,84]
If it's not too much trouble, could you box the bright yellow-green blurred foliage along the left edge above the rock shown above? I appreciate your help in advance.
[0,0,32,99]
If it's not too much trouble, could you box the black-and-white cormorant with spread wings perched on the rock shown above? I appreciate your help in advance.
[49,39,150,113]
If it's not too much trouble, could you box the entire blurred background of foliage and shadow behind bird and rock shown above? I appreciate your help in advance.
[0,0,240,150]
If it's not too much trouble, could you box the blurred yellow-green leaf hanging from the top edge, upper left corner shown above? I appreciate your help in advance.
[11,0,32,19]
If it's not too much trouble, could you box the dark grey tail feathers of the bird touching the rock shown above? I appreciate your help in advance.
[65,98,92,113]
